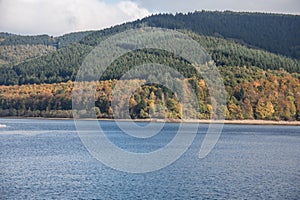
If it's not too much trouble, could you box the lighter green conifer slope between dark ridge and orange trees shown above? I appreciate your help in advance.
[0,31,300,85]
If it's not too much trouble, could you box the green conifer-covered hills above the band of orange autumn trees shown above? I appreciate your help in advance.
[0,11,300,85]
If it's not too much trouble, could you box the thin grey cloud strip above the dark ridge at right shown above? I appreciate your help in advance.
[133,0,300,14]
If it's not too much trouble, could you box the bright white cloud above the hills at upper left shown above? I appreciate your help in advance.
[0,0,149,35]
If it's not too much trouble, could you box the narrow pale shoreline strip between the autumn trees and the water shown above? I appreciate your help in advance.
[0,117,300,126]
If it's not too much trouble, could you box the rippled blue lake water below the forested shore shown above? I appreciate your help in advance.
[0,119,300,199]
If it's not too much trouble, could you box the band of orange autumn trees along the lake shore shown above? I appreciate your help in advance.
[0,67,300,120]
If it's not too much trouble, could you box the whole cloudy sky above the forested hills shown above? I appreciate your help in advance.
[0,0,300,36]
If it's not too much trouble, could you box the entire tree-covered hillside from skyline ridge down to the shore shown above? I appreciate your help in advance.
[0,11,300,120]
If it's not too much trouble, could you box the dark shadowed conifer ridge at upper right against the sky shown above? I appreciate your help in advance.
[142,11,300,59]
